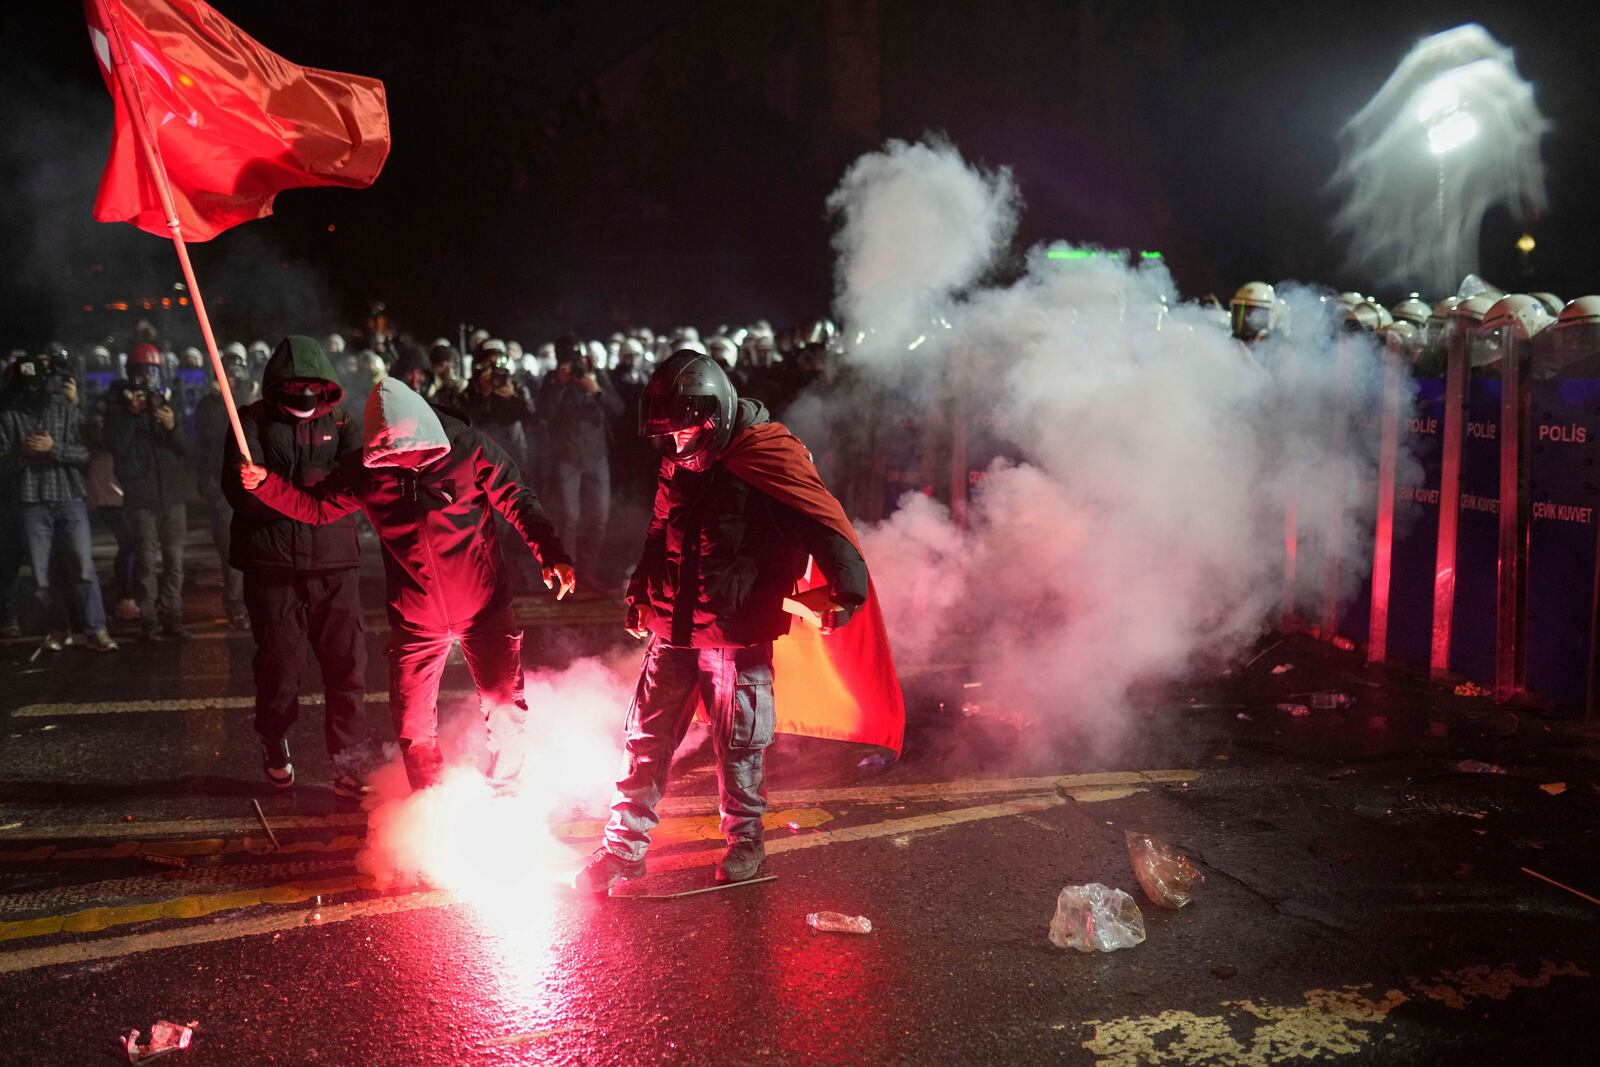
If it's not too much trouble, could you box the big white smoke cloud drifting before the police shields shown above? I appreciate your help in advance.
[827,144,1379,742]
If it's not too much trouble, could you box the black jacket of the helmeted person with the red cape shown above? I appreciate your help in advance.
[627,400,867,648]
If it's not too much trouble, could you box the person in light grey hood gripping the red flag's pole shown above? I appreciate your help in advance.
[242,378,573,792]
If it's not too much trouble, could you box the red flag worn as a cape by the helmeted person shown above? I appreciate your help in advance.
[720,422,906,753]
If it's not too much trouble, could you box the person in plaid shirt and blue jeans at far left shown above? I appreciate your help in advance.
[0,355,117,653]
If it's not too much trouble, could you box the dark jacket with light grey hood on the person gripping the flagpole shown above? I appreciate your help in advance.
[256,379,568,632]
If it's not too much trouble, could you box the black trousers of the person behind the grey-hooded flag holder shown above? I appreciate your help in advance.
[245,568,366,773]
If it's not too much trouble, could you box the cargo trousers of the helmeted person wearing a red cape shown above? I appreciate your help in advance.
[605,638,778,859]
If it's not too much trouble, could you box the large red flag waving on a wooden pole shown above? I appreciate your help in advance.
[83,0,389,242]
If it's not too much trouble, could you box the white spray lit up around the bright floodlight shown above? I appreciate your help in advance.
[1333,24,1550,294]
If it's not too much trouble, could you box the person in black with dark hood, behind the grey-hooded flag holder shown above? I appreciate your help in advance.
[221,336,366,800]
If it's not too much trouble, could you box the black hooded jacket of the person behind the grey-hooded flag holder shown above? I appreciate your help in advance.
[218,347,362,573]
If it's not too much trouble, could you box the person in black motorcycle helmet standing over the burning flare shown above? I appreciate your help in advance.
[576,350,896,894]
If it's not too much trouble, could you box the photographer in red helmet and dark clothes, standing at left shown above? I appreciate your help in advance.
[106,341,192,641]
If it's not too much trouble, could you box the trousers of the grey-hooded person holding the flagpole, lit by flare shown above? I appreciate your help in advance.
[389,601,528,790]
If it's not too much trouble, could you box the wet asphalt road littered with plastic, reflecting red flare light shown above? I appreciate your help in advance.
[0,556,1600,1067]
